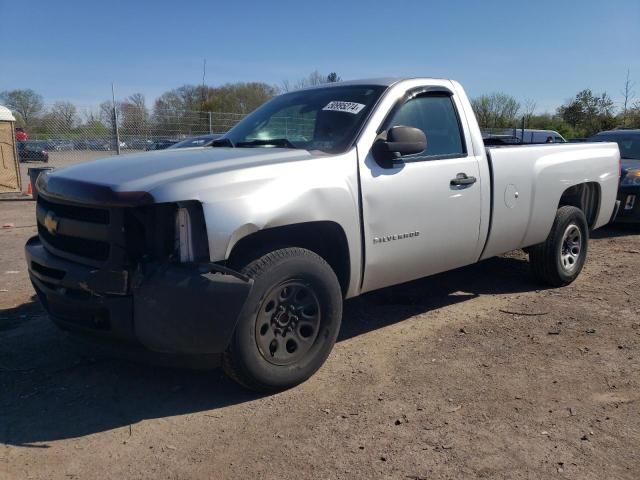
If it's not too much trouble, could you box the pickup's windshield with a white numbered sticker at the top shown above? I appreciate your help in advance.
[222,85,386,153]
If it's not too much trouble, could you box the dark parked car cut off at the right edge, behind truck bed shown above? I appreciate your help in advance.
[589,129,640,223]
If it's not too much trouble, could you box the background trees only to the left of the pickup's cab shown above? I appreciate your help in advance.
[0,71,341,137]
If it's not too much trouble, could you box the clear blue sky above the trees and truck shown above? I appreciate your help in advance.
[0,0,640,111]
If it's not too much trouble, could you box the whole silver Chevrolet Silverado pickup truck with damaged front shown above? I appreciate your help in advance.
[26,78,620,391]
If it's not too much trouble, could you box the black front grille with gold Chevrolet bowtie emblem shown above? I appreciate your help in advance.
[36,195,113,267]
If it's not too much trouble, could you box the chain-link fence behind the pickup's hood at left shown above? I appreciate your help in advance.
[16,106,250,191]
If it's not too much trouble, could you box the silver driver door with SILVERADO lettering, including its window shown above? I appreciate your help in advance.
[360,92,481,291]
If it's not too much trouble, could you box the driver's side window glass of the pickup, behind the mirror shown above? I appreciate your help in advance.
[387,95,466,160]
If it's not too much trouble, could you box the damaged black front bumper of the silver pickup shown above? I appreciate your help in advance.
[25,237,253,354]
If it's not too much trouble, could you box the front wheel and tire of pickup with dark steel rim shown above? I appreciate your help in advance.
[222,248,342,392]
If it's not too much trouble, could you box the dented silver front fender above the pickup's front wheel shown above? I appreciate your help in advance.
[202,149,361,295]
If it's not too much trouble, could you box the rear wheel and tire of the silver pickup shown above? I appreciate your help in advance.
[529,206,589,287]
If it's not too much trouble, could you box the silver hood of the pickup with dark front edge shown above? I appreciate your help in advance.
[37,147,314,205]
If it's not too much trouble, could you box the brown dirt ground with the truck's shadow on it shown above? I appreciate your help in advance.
[0,201,640,480]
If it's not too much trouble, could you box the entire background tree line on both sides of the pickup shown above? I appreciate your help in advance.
[0,71,640,138]
